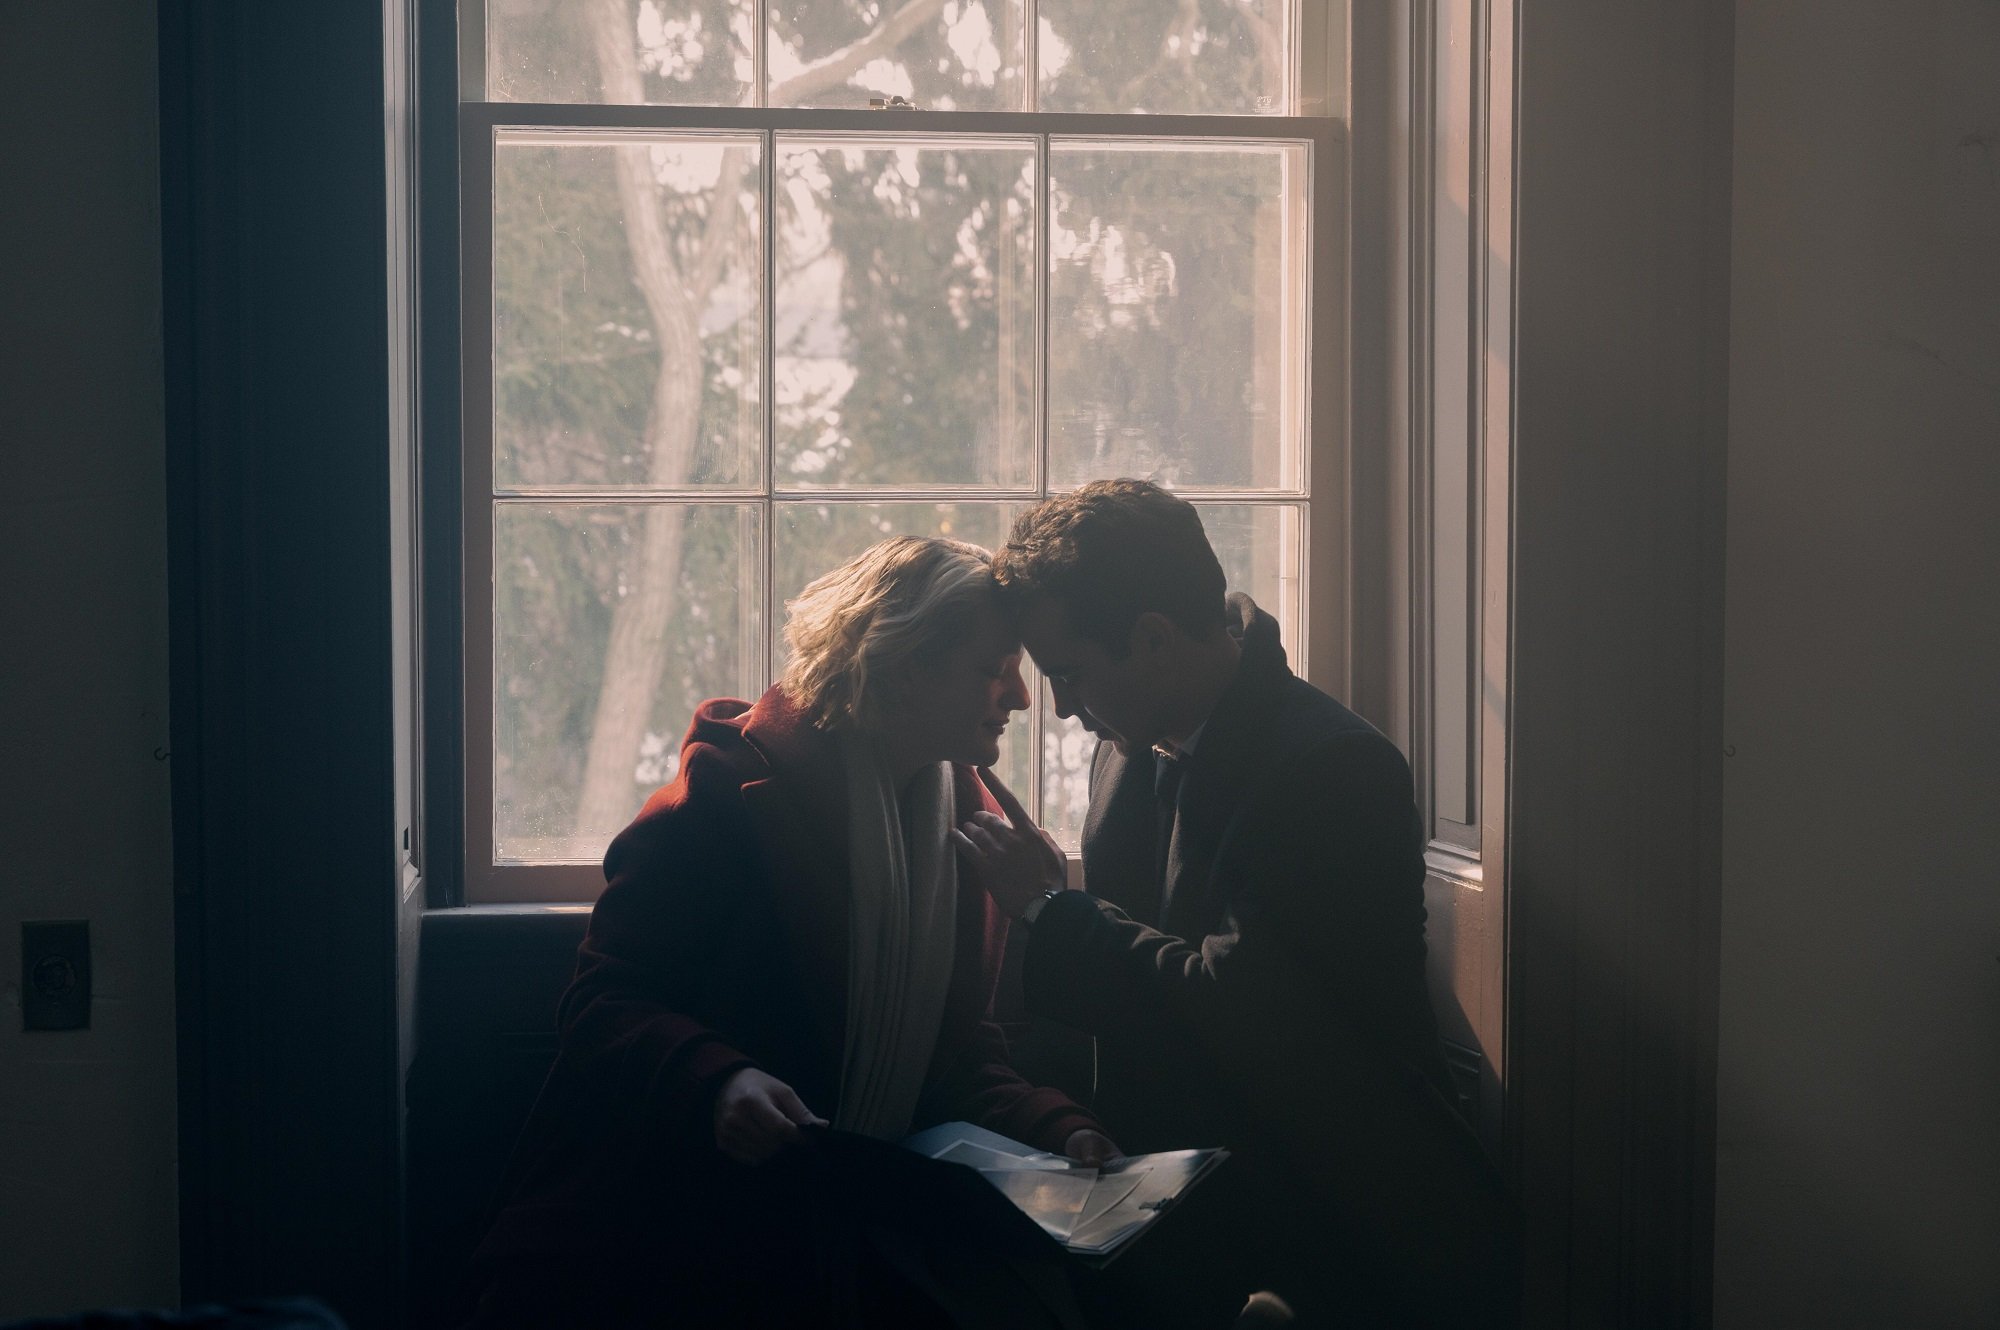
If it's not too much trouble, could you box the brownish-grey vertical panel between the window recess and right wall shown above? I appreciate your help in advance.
[1506,0,1728,1330]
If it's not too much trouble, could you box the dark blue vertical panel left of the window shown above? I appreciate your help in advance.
[160,2,400,1326]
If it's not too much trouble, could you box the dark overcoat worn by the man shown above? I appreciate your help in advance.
[1024,596,1512,1324]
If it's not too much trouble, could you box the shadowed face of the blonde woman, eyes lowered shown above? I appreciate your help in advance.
[888,600,1028,766]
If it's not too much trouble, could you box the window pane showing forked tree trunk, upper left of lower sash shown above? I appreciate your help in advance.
[494,132,764,490]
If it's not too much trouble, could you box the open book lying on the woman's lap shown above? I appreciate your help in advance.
[902,1122,1230,1260]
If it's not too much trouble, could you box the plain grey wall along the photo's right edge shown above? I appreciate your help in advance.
[1714,0,2000,1328]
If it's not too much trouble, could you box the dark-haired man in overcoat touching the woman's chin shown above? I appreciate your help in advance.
[960,480,1514,1326]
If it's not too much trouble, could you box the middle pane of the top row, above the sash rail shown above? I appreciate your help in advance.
[766,0,1028,110]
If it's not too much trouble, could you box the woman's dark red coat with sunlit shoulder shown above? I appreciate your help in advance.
[472,688,1098,1326]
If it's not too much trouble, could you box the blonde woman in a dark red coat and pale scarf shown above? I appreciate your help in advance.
[472,538,1116,1328]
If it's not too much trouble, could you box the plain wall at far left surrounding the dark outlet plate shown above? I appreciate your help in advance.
[0,0,178,1320]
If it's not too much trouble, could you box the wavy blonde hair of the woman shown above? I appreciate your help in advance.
[778,536,998,730]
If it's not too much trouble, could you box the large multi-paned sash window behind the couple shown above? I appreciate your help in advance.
[460,0,1344,900]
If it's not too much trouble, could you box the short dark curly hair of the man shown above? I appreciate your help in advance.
[994,480,1228,658]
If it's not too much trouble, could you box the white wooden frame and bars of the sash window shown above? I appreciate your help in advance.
[458,0,1352,904]
